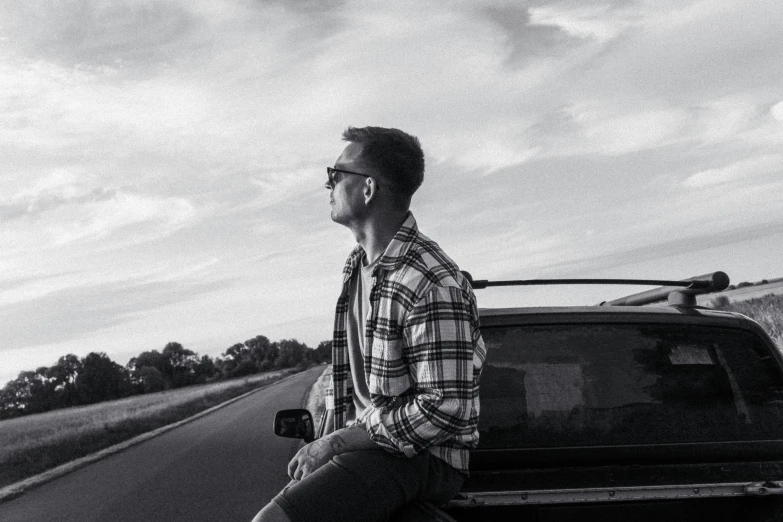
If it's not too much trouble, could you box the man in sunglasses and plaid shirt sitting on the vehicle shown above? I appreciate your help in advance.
[254,127,486,522]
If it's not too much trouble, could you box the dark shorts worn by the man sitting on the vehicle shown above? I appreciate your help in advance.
[272,449,466,522]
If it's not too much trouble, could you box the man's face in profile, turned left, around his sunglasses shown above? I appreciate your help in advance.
[325,143,370,225]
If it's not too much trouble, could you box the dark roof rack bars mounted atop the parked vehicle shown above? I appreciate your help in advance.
[462,270,729,306]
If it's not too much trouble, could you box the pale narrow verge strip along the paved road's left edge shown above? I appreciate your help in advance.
[0,370,307,504]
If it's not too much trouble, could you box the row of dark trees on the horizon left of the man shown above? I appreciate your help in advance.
[0,335,332,419]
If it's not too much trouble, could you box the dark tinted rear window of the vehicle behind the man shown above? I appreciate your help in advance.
[479,325,783,449]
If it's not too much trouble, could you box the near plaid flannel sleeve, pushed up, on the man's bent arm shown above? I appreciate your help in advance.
[363,286,477,457]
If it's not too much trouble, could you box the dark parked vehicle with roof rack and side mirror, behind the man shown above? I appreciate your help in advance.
[275,272,783,522]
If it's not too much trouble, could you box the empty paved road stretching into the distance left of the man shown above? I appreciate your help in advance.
[0,366,324,522]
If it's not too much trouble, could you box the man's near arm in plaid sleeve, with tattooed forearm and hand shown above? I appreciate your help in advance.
[288,287,477,480]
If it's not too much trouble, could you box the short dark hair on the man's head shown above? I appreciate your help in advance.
[343,127,424,199]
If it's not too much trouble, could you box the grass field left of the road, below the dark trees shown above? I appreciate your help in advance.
[0,370,292,488]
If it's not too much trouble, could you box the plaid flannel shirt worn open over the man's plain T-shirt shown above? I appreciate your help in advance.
[326,213,486,474]
